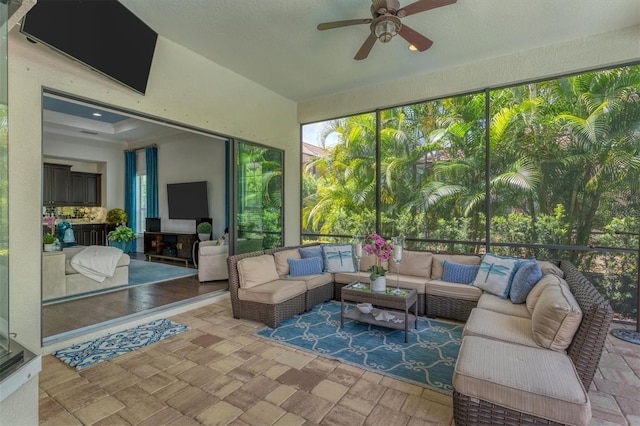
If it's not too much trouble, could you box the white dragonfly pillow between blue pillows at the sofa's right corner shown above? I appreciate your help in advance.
[471,253,521,299]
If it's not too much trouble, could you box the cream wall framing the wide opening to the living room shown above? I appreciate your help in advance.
[9,27,300,353]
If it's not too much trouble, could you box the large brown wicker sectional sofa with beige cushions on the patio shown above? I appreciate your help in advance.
[227,247,613,425]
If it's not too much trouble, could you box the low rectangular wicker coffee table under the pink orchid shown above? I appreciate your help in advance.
[340,283,418,343]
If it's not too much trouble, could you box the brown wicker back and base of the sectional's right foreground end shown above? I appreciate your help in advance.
[453,260,613,426]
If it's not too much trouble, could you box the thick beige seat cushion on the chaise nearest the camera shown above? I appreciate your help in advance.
[453,336,591,425]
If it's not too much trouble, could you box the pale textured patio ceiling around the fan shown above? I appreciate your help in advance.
[120,0,640,101]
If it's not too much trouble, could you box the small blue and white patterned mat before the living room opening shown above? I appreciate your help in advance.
[53,319,189,370]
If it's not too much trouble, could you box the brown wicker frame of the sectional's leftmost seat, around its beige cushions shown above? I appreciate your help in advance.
[227,251,305,328]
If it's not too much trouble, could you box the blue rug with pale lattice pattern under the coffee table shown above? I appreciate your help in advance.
[256,302,464,394]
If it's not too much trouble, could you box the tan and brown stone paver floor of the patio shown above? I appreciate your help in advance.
[39,299,640,426]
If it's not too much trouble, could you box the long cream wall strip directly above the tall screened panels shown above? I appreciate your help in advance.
[298,26,640,123]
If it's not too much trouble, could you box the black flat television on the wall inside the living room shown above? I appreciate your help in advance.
[167,181,209,219]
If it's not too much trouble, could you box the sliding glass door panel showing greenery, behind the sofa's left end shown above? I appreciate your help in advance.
[232,141,284,253]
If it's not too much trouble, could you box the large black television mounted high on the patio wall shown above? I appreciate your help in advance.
[20,0,158,94]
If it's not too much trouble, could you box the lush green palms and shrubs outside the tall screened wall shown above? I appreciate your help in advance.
[302,66,640,322]
